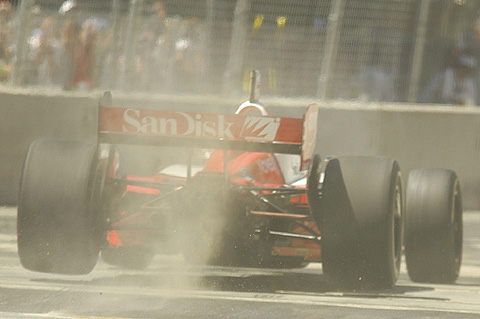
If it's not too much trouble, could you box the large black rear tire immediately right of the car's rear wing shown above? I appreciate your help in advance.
[314,156,404,290]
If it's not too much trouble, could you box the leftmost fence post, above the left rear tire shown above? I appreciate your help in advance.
[10,0,35,85]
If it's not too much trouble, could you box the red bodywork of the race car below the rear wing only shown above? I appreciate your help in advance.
[107,151,321,262]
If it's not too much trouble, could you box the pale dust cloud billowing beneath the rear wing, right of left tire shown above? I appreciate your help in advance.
[99,145,235,291]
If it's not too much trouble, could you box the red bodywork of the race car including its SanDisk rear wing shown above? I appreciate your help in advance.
[99,106,321,262]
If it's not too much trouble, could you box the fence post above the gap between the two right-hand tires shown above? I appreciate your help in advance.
[408,0,430,103]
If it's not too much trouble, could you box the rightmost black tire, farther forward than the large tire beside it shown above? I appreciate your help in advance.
[405,169,463,284]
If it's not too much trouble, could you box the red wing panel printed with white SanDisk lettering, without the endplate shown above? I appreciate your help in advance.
[99,107,303,143]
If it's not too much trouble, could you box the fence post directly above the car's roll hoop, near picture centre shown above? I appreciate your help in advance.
[223,0,251,94]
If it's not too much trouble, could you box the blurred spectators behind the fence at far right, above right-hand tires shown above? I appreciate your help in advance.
[354,23,480,107]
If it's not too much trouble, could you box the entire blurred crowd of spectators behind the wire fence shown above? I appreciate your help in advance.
[0,0,480,106]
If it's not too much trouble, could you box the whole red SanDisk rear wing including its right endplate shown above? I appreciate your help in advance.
[98,94,318,170]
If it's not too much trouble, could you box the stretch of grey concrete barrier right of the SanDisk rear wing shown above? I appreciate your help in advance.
[317,105,480,209]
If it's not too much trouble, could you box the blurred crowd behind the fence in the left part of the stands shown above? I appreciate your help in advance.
[0,0,205,92]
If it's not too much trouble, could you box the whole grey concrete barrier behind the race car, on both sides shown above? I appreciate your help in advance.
[0,88,480,209]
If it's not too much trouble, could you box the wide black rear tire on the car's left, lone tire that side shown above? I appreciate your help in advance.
[17,139,104,275]
